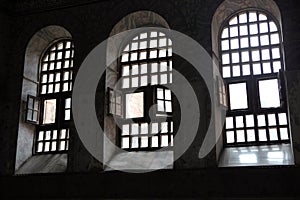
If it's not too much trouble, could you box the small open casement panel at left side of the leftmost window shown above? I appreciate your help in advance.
[25,95,40,124]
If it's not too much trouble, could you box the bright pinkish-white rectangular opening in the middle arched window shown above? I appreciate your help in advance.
[126,92,144,118]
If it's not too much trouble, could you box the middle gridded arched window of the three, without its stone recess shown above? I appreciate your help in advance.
[115,30,173,150]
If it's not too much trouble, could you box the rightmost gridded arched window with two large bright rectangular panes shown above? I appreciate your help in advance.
[219,10,289,146]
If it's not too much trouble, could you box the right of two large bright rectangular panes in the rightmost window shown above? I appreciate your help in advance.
[259,79,280,108]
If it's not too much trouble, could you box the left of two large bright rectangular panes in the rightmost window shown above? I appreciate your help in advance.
[229,83,248,110]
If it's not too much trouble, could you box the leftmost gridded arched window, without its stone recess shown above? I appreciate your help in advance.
[32,40,74,153]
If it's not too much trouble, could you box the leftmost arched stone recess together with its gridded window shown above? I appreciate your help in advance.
[15,25,74,174]
